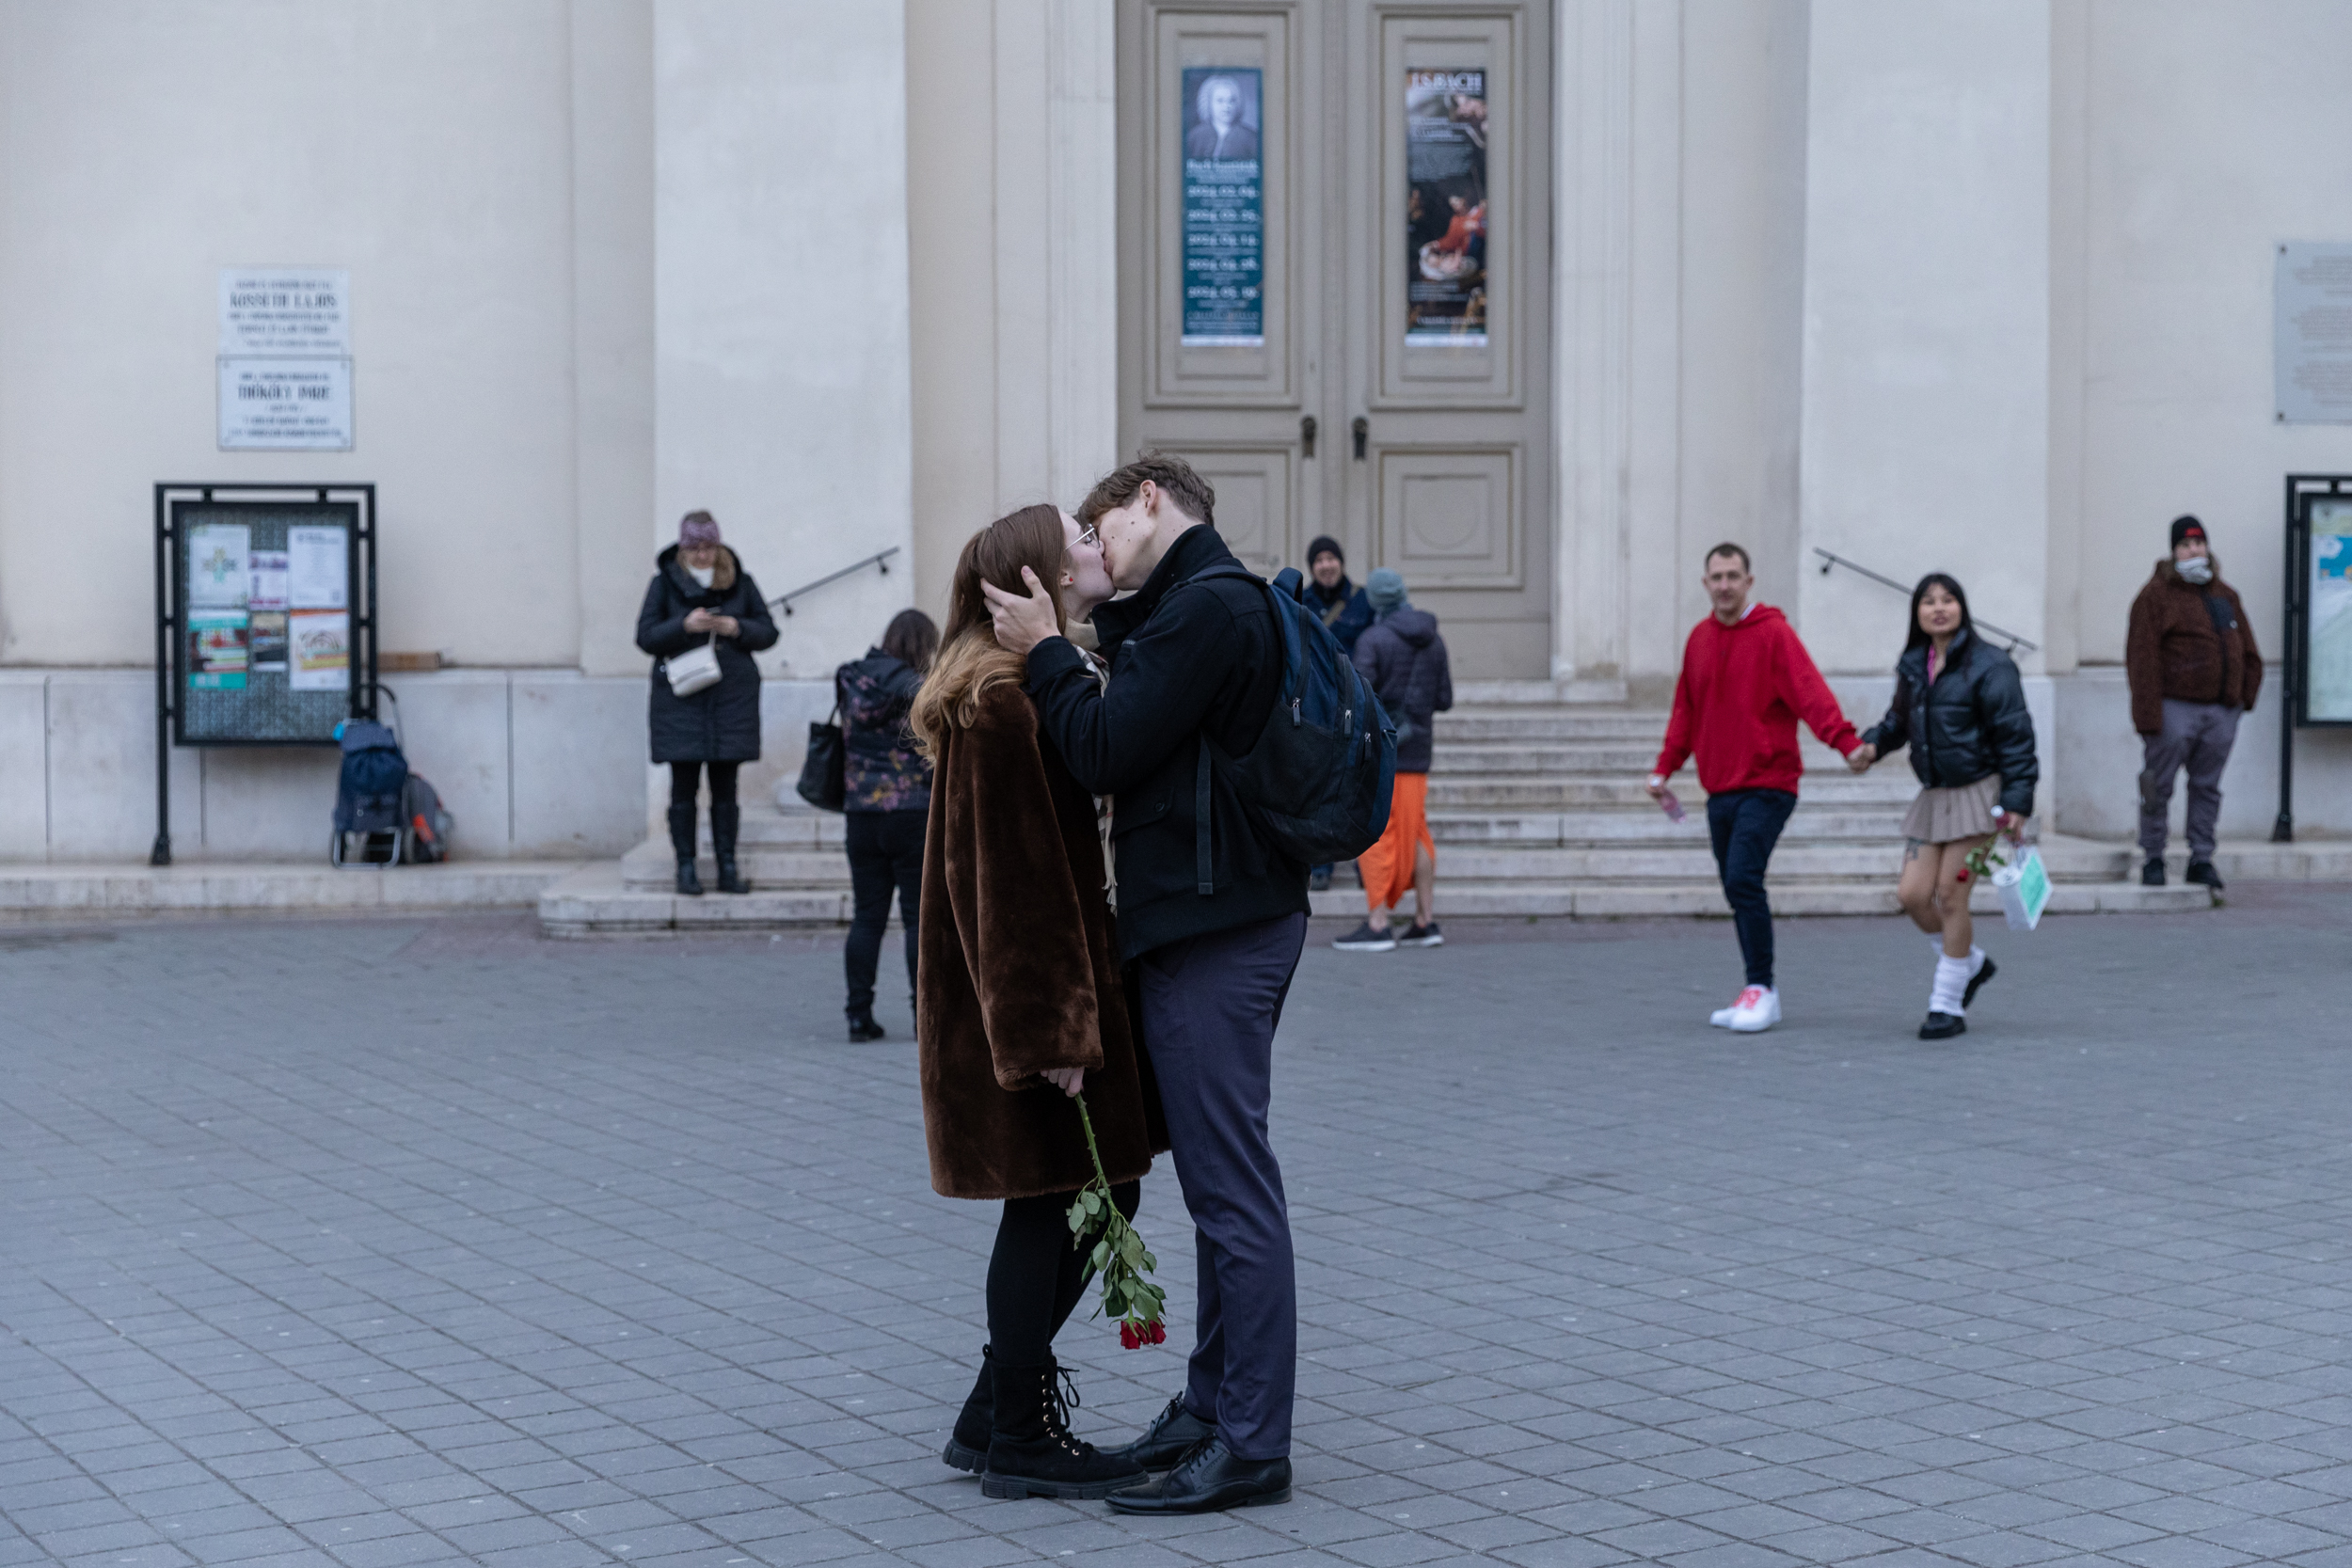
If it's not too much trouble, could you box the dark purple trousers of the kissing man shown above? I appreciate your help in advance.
[1136,914,1308,1460]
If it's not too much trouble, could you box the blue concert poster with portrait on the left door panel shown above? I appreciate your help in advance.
[1179,66,1265,348]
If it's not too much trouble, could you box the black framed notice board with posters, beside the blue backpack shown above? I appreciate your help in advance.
[151,484,376,865]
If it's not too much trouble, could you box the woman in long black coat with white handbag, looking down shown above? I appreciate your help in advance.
[638,513,776,898]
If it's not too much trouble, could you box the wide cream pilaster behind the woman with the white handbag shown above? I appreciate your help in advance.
[663,0,913,686]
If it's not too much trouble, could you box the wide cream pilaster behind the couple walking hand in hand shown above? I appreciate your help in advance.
[1797,0,2051,676]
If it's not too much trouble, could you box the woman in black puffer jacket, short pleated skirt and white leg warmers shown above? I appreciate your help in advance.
[1847,571,2042,1039]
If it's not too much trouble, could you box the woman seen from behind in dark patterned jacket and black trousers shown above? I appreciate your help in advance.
[833,609,939,1041]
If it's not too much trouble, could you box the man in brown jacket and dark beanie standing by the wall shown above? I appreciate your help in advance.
[2124,517,2263,891]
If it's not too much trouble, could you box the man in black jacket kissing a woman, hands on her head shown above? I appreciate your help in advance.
[988,456,1308,1514]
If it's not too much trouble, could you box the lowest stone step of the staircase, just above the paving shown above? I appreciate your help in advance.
[539,861,2214,936]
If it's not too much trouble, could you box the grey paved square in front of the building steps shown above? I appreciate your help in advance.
[0,886,2352,1568]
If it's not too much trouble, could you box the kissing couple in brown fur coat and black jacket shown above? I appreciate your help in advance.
[911,456,1308,1514]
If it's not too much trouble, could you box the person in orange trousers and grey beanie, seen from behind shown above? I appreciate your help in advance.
[1331,566,1454,952]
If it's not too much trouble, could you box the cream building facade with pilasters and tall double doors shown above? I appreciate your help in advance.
[0,0,2352,861]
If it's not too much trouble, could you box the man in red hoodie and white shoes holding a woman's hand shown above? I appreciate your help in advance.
[1649,546,1863,1035]
